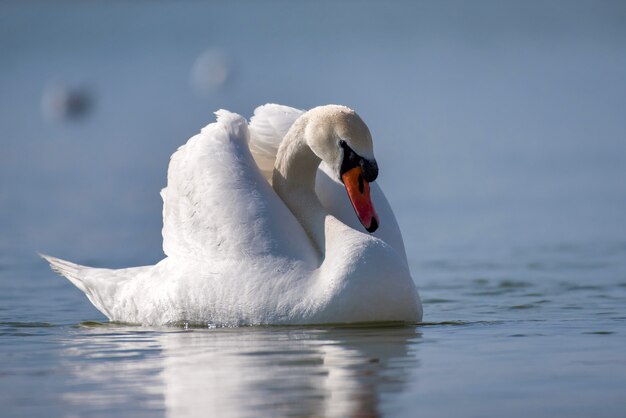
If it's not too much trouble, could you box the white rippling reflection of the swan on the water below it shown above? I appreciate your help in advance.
[63,324,420,417]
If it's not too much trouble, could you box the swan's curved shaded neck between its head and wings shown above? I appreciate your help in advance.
[272,117,328,258]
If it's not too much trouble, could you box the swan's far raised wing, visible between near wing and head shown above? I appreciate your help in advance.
[248,103,304,183]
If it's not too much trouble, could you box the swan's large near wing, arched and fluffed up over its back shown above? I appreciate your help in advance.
[161,110,317,261]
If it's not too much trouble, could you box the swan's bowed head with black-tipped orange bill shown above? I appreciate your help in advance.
[305,105,379,233]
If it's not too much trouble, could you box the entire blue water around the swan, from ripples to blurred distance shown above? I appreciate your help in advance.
[0,1,626,417]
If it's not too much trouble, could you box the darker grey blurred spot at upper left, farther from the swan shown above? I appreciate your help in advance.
[41,81,94,122]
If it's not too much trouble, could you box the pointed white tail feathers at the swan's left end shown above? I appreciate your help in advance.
[39,254,137,320]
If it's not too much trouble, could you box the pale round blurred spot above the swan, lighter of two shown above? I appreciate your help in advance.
[191,49,232,94]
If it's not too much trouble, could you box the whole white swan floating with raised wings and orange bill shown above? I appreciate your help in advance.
[43,105,422,325]
